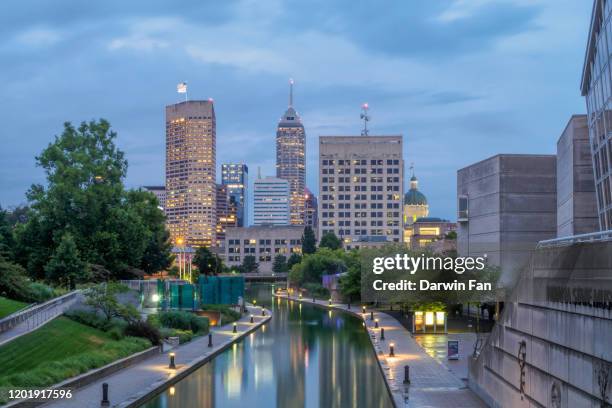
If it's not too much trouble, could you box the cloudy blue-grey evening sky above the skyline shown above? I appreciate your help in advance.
[0,0,592,219]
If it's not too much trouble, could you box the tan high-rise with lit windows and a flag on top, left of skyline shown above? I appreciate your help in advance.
[166,101,217,247]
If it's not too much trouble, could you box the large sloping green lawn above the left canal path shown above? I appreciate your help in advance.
[0,316,151,396]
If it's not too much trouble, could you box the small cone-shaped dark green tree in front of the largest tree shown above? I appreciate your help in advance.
[45,233,88,290]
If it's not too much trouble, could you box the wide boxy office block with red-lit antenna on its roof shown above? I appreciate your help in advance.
[319,135,404,249]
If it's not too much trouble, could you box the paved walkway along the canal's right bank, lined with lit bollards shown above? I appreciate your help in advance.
[275,294,486,408]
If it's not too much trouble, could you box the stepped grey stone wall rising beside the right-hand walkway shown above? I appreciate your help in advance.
[468,238,612,408]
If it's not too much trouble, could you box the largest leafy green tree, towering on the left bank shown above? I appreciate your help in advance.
[16,119,170,279]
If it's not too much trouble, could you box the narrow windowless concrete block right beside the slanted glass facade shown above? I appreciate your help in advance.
[557,115,599,237]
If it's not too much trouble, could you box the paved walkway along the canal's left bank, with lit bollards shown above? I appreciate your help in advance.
[44,306,272,408]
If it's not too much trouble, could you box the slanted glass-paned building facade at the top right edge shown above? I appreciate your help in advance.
[581,0,612,230]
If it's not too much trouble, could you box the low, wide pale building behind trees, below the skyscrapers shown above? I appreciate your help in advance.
[225,225,304,273]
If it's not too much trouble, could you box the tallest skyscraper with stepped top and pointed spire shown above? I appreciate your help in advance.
[276,80,306,225]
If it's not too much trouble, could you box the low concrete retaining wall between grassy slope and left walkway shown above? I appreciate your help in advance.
[4,346,161,408]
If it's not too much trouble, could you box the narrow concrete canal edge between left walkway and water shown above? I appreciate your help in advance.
[116,309,272,408]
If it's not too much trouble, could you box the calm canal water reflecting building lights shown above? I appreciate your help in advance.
[142,284,392,408]
